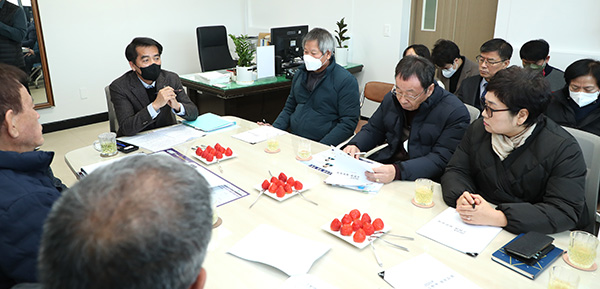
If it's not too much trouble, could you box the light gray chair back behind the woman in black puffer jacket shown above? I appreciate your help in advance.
[563,126,600,235]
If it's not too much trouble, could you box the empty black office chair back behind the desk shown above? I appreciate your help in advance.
[196,25,236,72]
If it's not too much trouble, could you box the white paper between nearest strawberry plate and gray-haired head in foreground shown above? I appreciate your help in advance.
[228,224,330,276]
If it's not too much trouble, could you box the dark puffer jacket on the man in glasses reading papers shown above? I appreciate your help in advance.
[348,85,470,181]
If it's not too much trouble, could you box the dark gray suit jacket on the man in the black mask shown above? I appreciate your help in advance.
[110,70,198,136]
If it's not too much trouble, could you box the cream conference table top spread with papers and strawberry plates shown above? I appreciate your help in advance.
[65,116,600,288]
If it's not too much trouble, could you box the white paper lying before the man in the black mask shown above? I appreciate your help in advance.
[119,124,206,152]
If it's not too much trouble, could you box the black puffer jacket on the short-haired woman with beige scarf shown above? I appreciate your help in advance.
[442,116,589,234]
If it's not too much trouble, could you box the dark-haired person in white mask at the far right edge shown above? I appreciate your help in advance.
[546,59,600,135]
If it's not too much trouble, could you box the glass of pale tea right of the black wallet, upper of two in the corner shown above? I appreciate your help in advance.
[567,231,598,269]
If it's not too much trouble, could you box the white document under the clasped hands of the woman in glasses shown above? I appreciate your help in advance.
[417,208,502,257]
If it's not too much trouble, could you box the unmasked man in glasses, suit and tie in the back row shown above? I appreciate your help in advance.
[456,38,513,110]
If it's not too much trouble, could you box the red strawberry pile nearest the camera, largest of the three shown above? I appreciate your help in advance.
[329,209,383,243]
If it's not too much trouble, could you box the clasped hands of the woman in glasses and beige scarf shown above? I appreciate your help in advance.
[456,191,508,227]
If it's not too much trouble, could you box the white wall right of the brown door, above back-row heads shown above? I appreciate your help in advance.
[494,0,600,70]
